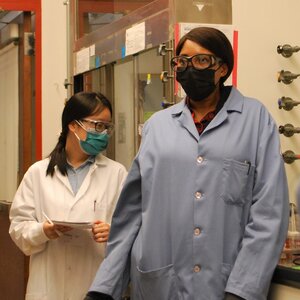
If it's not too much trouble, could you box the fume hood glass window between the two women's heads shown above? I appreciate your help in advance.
[114,48,165,168]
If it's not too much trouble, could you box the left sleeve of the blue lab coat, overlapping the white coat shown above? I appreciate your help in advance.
[89,123,149,300]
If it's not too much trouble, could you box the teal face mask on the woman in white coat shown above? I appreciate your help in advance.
[75,131,109,155]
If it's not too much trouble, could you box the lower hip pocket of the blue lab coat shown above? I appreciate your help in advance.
[137,265,181,300]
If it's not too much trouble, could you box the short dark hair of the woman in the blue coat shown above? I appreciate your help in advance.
[176,27,234,84]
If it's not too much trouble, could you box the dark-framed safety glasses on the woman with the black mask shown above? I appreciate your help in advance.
[171,54,222,73]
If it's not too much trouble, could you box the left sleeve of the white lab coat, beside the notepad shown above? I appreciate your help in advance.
[9,169,49,255]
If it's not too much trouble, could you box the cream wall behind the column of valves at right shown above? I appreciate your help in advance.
[232,0,300,206]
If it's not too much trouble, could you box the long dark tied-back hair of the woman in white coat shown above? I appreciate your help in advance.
[46,92,112,176]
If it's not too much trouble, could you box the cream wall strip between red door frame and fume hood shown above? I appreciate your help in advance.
[42,0,67,157]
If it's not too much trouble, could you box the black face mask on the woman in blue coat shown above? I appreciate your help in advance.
[176,67,216,101]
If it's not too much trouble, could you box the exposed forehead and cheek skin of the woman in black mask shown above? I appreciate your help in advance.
[179,40,228,84]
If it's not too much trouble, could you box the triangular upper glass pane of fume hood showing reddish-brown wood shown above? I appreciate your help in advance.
[77,0,154,38]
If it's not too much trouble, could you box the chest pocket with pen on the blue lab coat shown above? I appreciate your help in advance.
[221,159,252,206]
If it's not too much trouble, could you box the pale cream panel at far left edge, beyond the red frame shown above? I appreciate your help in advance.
[0,44,19,201]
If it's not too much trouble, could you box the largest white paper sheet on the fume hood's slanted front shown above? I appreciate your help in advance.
[125,22,145,56]
